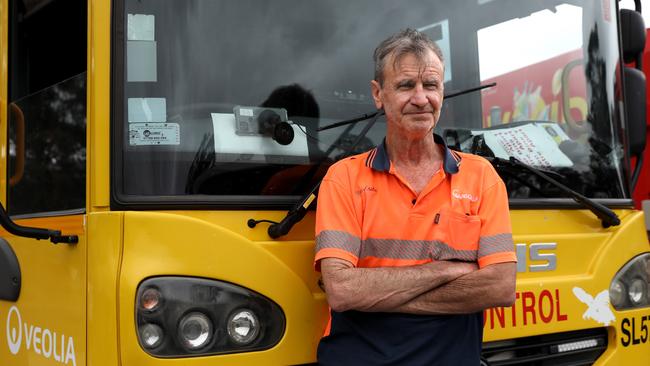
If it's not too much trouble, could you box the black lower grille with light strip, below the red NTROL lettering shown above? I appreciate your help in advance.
[482,328,607,366]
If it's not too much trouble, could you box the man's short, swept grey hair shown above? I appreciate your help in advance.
[373,28,445,86]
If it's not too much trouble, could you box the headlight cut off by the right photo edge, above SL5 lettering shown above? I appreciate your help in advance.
[609,253,650,310]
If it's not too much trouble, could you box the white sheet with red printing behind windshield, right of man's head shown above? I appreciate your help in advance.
[472,123,573,167]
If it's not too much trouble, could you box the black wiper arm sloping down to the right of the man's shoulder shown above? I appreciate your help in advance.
[486,156,621,228]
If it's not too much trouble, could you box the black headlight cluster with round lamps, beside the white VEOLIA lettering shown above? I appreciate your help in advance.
[135,277,285,357]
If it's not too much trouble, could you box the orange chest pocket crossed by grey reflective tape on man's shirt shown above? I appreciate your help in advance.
[432,209,481,262]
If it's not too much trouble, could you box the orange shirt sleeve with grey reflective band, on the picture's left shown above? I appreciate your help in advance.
[314,166,361,271]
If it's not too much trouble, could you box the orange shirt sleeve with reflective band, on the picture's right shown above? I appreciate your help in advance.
[478,177,517,268]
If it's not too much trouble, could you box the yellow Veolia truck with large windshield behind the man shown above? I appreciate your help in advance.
[0,0,650,366]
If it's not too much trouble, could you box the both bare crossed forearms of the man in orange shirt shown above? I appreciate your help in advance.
[321,258,516,314]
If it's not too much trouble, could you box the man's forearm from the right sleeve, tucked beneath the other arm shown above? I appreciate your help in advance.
[394,263,516,314]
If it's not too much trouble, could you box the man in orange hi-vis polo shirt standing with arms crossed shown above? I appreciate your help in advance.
[315,29,516,366]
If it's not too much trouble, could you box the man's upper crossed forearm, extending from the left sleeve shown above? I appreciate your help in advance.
[321,258,478,312]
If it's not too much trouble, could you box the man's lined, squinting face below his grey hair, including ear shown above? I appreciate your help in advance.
[371,51,444,138]
